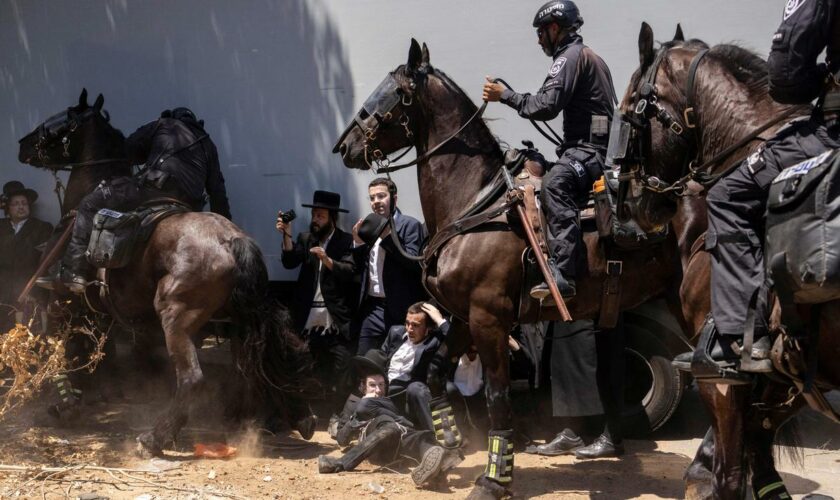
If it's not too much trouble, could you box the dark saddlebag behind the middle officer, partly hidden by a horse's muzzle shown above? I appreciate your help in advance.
[593,170,668,250]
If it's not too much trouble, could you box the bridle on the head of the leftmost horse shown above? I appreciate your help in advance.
[20,107,125,171]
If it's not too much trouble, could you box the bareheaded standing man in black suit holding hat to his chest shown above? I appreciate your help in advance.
[353,177,427,355]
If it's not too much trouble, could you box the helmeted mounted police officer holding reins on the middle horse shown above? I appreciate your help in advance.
[483,0,616,300]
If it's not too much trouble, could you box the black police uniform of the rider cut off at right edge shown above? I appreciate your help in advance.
[706,0,840,336]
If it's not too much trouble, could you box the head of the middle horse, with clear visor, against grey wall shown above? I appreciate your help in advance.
[333,39,434,170]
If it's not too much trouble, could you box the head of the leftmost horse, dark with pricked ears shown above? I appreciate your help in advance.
[18,89,111,169]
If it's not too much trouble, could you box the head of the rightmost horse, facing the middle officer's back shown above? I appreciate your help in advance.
[607,23,707,231]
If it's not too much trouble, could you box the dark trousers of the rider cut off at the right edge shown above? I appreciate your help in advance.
[706,118,840,336]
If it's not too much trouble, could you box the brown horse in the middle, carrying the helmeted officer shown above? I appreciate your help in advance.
[336,40,679,496]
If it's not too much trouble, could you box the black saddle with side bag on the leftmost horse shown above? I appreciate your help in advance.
[85,198,190,269]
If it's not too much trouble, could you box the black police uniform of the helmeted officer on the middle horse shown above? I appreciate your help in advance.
[501,33,616,278]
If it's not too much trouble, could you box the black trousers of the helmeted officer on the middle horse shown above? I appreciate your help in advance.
[540,146,604,278]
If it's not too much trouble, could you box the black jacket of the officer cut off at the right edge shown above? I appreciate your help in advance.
[767,0,840,104]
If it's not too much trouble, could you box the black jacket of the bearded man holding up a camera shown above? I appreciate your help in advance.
[281,228,359,338]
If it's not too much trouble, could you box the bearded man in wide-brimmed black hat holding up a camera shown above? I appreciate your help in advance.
[276,191,359,426]
